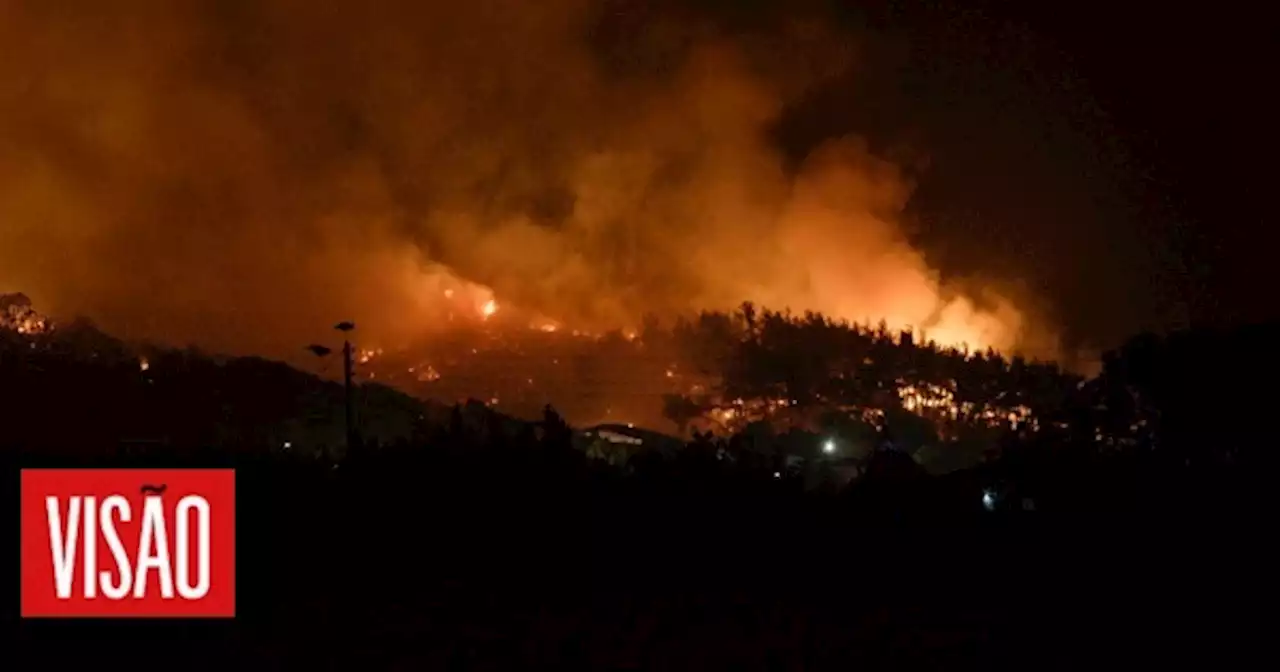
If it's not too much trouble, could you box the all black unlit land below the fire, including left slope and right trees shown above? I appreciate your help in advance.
[0,316,1276,669]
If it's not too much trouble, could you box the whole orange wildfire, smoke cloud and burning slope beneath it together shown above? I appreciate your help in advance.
[0,0,1105,468]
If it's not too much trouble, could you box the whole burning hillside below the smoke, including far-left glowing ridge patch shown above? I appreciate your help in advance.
[0,289,1153,471]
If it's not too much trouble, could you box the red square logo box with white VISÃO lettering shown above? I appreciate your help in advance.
[22,468,236,618]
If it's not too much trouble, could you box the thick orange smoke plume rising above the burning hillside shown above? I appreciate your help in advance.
[0,0,1053,355]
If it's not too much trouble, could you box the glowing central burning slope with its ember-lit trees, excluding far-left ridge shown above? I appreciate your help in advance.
[335,289,1076,450]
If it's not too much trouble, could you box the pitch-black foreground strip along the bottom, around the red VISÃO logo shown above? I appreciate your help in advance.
[5,442,1271,669]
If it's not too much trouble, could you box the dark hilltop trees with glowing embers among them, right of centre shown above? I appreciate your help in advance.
[663,302,1079,462]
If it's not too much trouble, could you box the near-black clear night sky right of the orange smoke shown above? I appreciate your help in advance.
[814,1,1277,342]
